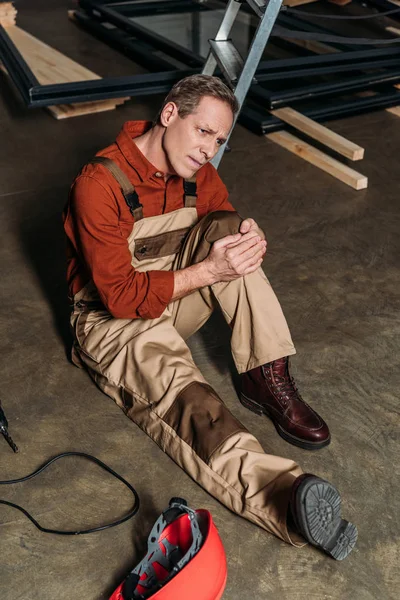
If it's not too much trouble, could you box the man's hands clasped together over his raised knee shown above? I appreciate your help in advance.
[203,230,267,285]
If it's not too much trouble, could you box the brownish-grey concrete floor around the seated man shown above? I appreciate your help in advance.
[0,0,400,600]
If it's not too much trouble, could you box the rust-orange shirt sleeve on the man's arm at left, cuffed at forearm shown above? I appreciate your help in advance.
[67,176,174,319]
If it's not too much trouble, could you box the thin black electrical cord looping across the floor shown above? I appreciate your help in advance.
[0,452,140,535]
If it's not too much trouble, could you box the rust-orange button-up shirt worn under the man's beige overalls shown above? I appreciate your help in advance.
[64,121,234,319]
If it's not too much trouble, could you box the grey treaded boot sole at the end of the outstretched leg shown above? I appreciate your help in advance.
[295,477,358,560]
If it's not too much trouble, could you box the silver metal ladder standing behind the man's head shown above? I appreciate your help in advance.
[202,0,282,168]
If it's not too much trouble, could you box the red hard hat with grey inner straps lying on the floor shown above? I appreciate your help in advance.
[110,498,227,600]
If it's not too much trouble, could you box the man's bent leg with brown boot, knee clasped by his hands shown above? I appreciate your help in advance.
[172,211,330,450]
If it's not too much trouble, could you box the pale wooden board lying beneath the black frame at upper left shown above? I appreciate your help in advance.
[2,26,128,119]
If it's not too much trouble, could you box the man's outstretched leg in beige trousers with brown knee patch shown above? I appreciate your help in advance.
[72,302,304,545]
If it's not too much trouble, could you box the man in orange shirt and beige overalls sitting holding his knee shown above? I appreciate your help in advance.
[65,75,357,559]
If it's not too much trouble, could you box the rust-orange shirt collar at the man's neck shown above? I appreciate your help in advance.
[116,121,158,181]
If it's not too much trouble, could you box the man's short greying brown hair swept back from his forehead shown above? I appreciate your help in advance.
[155,75,239,124]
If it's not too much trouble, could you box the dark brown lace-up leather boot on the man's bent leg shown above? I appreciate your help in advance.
[240,357,331,450]
